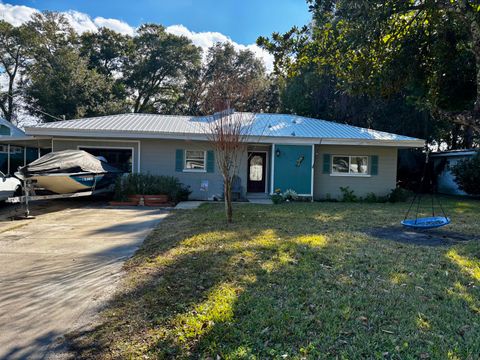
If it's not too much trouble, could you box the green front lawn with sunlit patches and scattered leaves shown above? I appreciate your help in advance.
[72,198,480,359]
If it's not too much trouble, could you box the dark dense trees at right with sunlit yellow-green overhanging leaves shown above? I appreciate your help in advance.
[257,0,480,148]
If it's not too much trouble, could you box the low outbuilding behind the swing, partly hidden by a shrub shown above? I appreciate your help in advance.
[431,150,477,195]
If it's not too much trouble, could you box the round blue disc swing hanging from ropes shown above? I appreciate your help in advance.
[400,146,451,230]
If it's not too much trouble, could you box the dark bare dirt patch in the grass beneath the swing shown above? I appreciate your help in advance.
[366,226,479,246]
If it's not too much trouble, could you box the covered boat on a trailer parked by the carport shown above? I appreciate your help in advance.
[15,150,123,195]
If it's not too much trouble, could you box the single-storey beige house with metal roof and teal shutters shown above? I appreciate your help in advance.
[0,113,424,199]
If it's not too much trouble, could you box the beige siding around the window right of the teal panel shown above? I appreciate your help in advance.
[313,145,397,200]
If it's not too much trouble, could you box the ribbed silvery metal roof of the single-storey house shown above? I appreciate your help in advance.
[26,112,423,146]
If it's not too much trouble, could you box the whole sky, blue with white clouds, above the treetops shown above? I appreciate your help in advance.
[0,0,310,70]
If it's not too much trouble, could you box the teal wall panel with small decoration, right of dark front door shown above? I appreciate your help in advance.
[273,145,313,196]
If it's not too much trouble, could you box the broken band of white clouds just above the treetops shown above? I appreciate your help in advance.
[0,0,273,71]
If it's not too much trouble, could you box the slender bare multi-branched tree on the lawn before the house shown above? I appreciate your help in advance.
[205,106,255,223]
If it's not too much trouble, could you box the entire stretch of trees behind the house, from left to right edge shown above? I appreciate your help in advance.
[0,0,480,149]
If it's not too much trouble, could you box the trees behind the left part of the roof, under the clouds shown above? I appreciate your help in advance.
[0,12,272,121]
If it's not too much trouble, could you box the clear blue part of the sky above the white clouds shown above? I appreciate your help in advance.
[3,0,310,45]
